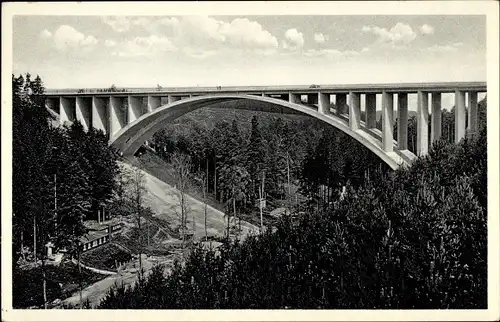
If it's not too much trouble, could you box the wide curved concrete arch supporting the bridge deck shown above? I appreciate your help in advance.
[110,94,416,170]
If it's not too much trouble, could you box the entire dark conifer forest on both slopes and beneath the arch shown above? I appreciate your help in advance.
[12,74,487,309]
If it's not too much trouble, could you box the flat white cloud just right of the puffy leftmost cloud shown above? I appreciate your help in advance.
[112,35,177,57]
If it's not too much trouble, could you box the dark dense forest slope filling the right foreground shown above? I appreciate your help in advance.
[99,127,487,309]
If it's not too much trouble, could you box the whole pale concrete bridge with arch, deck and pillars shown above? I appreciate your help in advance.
[46,82,486,169]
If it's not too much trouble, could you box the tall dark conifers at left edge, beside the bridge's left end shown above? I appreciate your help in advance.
[12,73,119,307]
